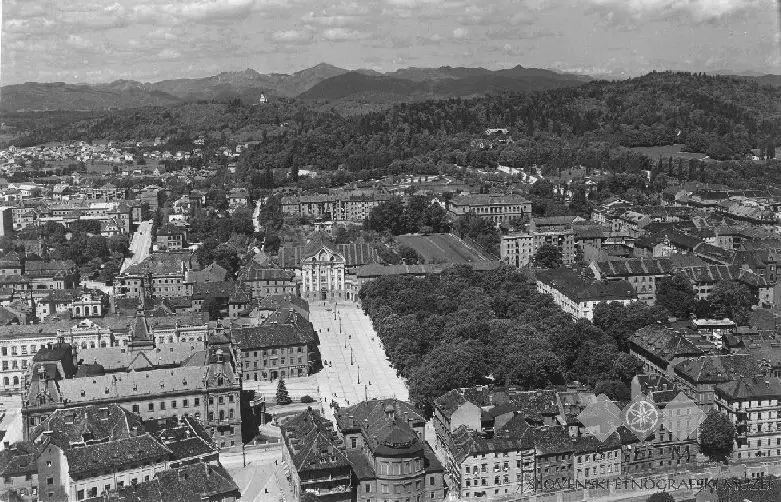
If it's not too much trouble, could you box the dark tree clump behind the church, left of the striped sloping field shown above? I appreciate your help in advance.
[364,195,450,235]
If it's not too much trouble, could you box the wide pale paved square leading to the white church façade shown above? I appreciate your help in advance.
[309,302,409,419]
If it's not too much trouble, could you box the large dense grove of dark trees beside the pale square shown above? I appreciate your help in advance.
[359,266,667,411]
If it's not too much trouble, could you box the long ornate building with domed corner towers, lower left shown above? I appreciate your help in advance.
[22,344,241,448]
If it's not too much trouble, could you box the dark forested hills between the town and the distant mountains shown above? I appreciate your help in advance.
[6,72,781,166]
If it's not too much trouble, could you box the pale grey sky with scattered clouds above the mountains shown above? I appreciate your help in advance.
[0,0,781,85]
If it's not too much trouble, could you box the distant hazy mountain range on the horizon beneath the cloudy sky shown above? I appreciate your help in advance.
[0,63,592,112]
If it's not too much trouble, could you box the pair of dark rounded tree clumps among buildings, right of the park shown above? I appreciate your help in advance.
[656,274,757,325]
